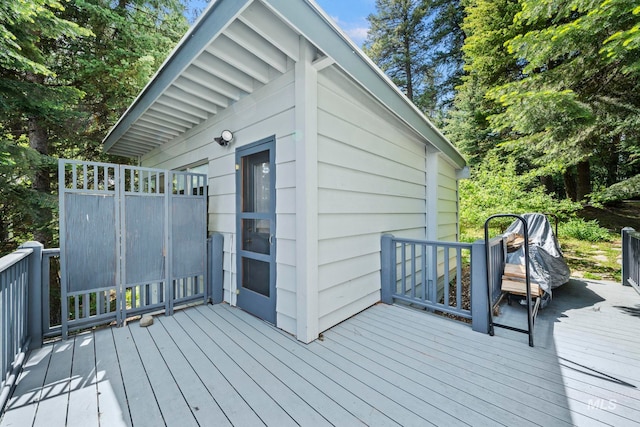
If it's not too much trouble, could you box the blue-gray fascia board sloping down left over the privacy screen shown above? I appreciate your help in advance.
[102,0,252,152]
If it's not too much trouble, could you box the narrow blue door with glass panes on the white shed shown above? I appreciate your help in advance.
[236,137,276,324]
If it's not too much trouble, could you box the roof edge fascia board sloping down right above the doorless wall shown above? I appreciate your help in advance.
[264,0,466,168]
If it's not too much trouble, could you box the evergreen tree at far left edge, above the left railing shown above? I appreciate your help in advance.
[0,0,90,253]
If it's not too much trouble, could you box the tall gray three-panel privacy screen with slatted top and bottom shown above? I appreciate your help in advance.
[58,159,208,337]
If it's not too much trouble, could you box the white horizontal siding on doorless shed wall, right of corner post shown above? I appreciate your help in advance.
[318,67,427,331]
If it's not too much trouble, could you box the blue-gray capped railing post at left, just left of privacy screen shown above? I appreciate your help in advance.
[20,242,44,348]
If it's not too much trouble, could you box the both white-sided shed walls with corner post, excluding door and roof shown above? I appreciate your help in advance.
[142,59,457,341]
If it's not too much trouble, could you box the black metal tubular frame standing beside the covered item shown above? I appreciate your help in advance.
[484,214,538,347]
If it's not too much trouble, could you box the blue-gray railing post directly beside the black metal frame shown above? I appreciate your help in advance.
[471,240,490,334]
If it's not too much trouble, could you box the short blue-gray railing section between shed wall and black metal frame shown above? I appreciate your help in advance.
[381,234,488,333]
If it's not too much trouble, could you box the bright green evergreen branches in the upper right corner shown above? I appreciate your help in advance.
[487,0,640,200]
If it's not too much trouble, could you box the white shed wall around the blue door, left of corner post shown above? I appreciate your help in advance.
[142,69,296,334]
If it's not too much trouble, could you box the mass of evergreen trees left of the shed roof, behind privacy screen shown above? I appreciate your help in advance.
[0,0,187,249]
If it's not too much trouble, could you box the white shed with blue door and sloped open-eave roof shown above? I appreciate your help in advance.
[104,0,465,342]
